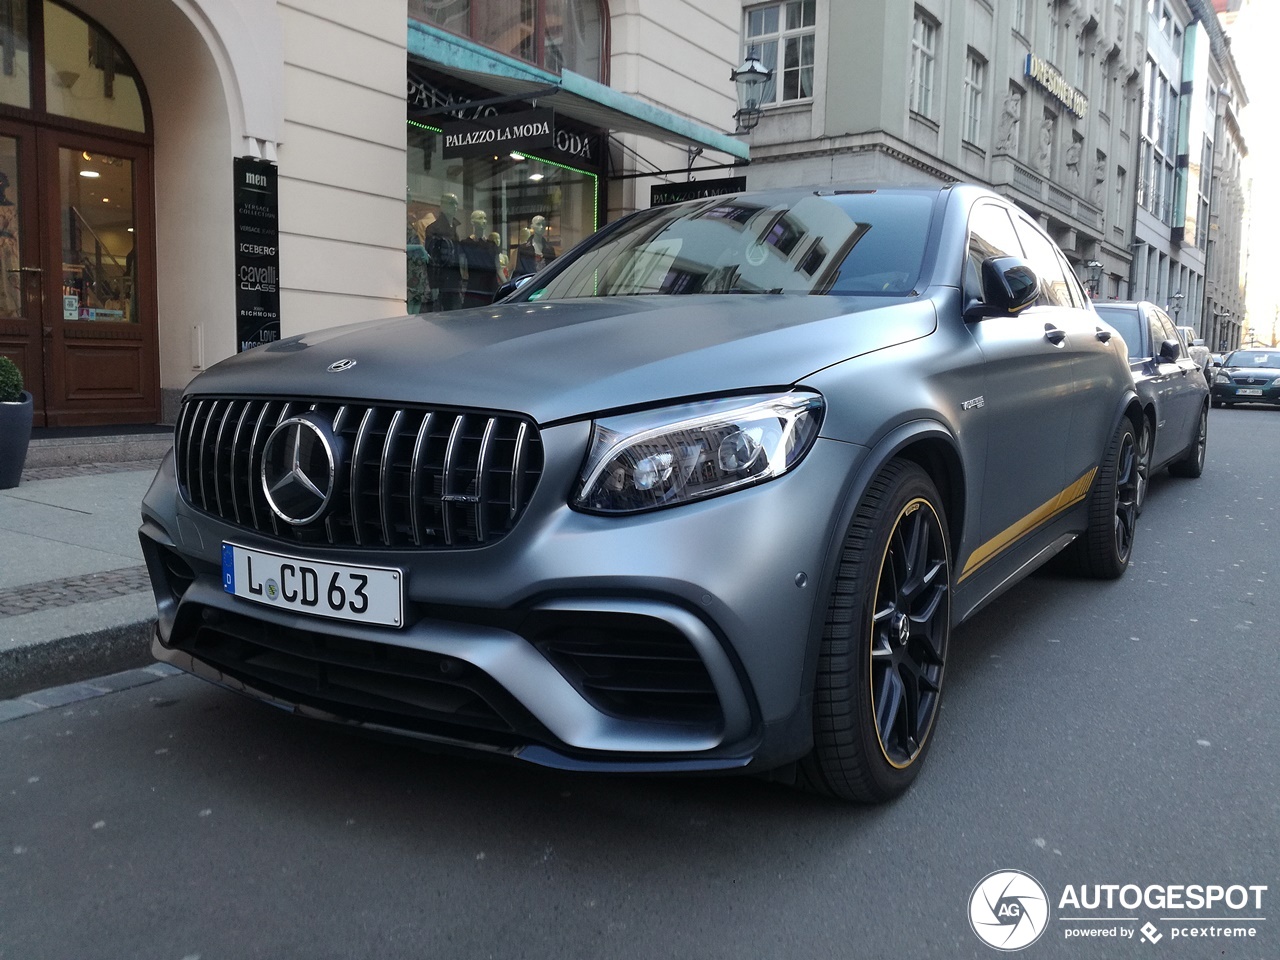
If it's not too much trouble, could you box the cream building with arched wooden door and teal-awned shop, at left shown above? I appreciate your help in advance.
[0,0,749,426]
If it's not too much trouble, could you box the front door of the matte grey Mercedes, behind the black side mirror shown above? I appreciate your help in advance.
[961,201,1074,568]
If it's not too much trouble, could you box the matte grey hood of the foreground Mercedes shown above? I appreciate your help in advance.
[188,294,937,424]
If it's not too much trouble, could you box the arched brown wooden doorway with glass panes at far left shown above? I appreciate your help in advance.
[0,0,160,426]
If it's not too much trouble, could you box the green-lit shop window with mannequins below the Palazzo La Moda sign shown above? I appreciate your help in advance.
[404,122,598,314]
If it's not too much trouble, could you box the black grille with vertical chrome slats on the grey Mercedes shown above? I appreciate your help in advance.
[174,397,543,548]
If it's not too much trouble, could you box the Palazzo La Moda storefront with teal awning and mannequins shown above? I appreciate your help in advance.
[406,15,748,312]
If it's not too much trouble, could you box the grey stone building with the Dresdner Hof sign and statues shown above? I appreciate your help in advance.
[742,0,1143,298]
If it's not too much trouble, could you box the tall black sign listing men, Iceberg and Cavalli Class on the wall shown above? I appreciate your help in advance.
[234,156,280,351]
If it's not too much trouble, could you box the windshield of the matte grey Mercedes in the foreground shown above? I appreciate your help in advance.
[527,192,937,300]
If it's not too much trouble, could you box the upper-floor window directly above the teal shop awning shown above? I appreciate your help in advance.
[408,0,608,83]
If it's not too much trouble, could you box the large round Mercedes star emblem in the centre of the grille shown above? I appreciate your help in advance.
[262,417,337,526]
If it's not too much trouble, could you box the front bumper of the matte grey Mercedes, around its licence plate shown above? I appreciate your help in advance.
[141,424,863,771]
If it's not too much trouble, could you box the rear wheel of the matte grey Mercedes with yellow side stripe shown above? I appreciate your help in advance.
[1073,417,1138,580]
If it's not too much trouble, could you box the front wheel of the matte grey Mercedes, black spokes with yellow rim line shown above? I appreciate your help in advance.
[797,460,952,803]
